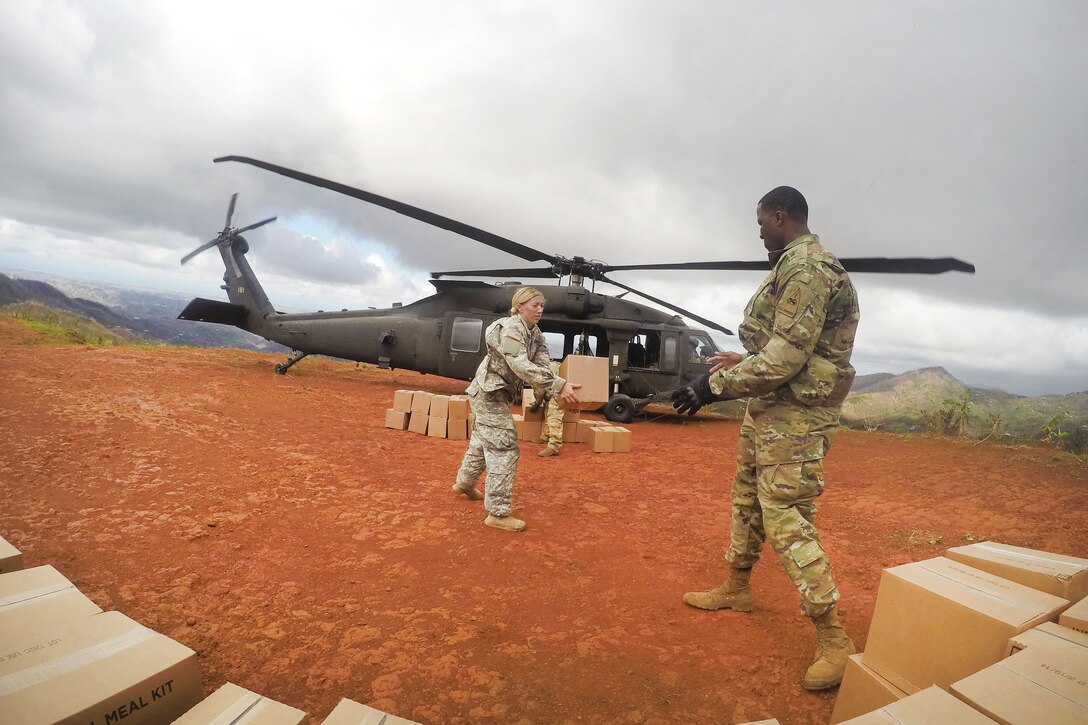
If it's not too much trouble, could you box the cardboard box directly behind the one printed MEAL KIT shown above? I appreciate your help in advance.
[0,566,102,644]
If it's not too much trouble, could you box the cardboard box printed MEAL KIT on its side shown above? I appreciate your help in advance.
[0,612,201,725]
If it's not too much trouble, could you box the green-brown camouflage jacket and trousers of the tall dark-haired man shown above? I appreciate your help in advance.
[709,234,858,618]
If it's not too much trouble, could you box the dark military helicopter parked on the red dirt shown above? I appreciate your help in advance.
[178,156,975,422]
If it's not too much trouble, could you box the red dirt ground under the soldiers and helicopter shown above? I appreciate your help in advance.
[0,319,1088,725]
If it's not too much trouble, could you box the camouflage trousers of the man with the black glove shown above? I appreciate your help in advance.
[726,398,839,618]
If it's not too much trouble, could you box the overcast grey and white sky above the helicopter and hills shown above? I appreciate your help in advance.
[0,0,1088,394]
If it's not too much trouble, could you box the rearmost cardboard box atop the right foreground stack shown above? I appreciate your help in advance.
[944,541,1088,602]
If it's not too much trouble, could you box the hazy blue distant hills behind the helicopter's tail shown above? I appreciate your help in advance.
[0,269,287,352]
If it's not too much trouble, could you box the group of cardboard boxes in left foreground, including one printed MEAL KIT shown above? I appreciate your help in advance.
[0,524,412,725]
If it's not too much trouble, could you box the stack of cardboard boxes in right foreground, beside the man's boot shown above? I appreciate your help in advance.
[831,542,1088,725]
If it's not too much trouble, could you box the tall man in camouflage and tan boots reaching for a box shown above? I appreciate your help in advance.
[672,186,858,690]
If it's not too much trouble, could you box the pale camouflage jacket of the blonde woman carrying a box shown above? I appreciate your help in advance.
[466,315,567,428]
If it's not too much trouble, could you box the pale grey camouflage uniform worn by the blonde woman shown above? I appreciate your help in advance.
[457,315,566,516]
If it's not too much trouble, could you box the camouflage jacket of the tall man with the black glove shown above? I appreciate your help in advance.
[710,234,860,407]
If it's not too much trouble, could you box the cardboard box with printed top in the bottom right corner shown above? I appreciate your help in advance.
[951,647,1088,725]
